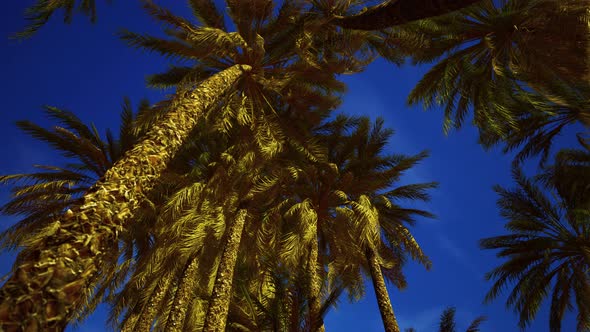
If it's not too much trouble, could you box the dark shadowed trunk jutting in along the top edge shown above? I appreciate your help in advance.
[331,0,480,30]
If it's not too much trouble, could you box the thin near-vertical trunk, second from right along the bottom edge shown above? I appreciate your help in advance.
[307,223,325,332]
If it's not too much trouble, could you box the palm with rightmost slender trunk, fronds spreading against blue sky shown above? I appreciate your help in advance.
[328,119,436,331]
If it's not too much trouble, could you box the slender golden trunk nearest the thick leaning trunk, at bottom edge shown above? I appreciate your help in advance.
[121,275,172,332]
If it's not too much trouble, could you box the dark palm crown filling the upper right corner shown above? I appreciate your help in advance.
[402,0,590,141]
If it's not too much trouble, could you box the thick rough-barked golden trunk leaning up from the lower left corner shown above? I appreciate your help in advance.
[0,65,250,331]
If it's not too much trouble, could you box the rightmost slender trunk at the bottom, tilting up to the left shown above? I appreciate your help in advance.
[366,249,399,332]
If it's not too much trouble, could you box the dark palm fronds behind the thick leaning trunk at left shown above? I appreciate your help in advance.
[0,99,166,326]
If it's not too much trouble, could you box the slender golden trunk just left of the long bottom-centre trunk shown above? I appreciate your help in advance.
[164,255,199,332]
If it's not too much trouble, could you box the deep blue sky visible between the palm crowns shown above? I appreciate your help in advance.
[0,0,575,332]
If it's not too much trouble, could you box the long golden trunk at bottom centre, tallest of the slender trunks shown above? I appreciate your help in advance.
[203,209,248,332]
